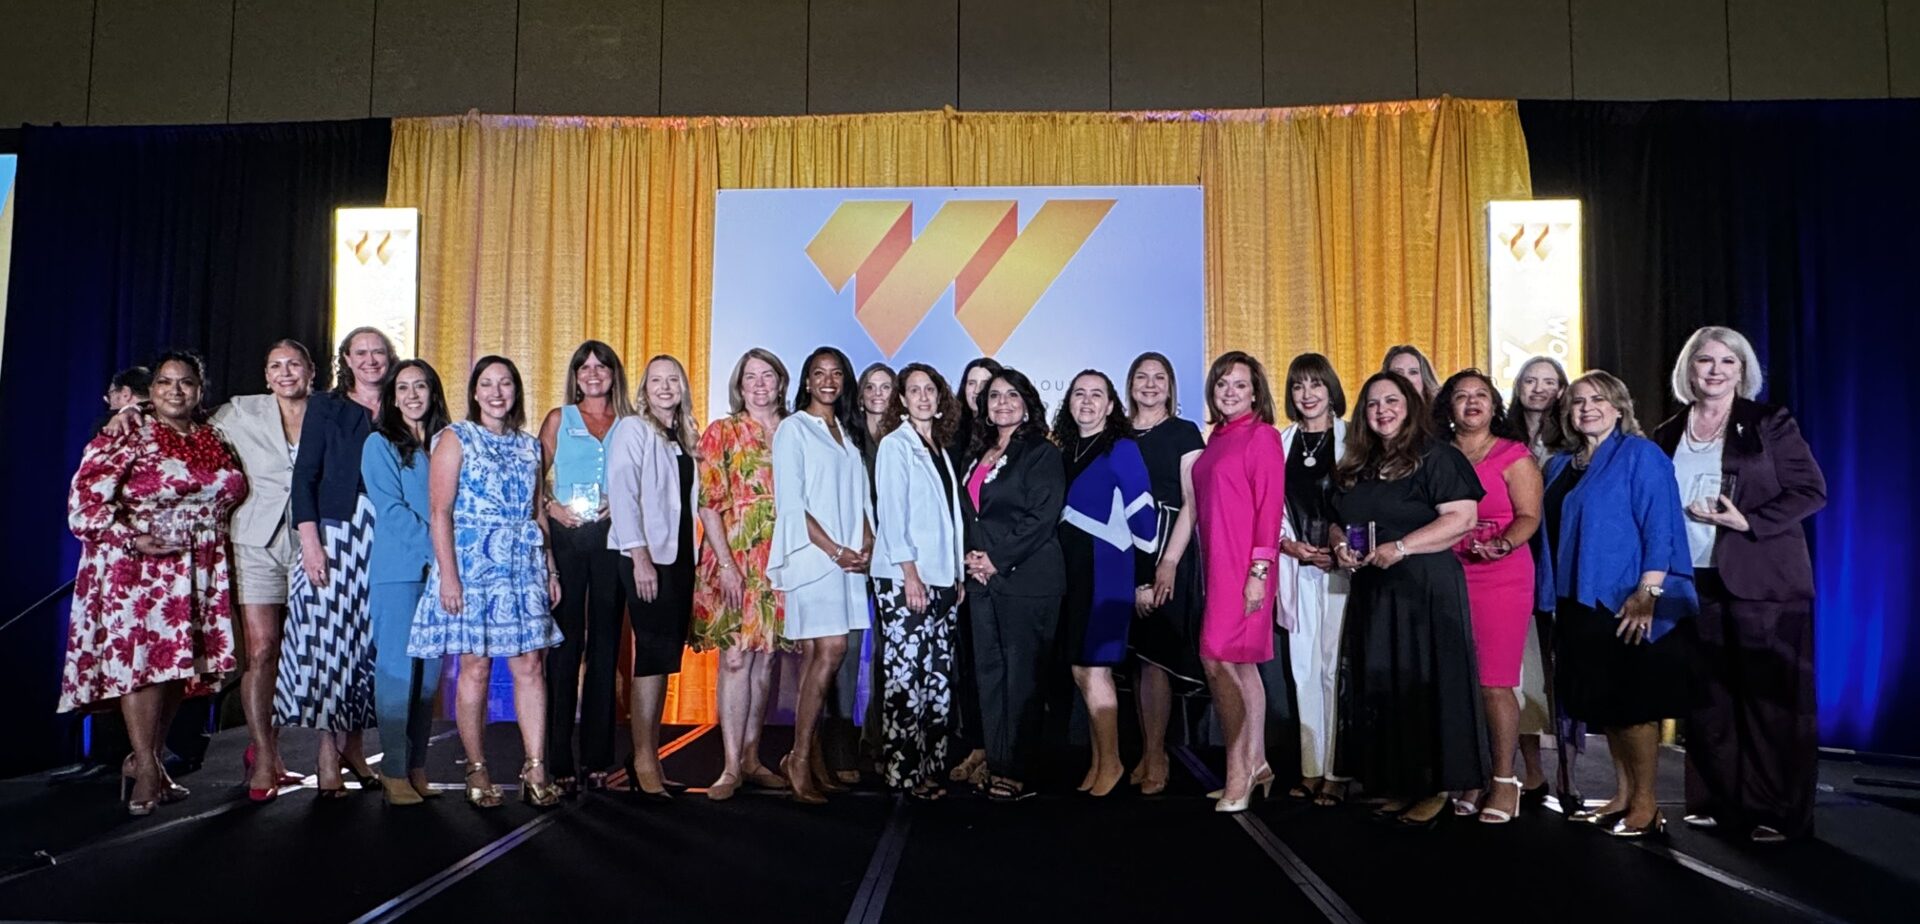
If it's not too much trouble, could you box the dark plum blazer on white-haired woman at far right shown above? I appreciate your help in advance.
[1653,398,1826,601]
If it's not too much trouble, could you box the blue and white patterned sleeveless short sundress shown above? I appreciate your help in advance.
[407,421,561,657]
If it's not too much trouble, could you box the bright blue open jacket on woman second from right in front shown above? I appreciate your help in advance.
[1534,432,1699,638]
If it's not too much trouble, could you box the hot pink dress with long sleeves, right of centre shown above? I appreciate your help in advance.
[1192,413,1286,665]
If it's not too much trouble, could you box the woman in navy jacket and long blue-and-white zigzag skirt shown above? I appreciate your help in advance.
[273,327,394,797]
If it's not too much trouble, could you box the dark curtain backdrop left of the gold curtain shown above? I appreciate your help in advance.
[0,119,392,776]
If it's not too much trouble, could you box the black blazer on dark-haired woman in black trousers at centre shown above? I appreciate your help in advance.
[954,436,1068,597]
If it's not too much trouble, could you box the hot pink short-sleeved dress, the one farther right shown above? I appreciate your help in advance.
[1453,440,1534,686]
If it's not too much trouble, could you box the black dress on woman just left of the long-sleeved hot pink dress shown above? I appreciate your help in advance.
[1129,417,1206,684]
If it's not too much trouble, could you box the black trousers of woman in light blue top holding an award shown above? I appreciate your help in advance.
[547,519,632,776]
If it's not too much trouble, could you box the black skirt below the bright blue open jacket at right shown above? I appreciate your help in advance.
[1553,597,1693,728]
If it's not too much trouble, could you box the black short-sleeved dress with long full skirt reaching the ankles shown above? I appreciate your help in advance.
[1334,444,1488,797]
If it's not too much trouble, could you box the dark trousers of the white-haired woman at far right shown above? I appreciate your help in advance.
[1686,569,1820,838]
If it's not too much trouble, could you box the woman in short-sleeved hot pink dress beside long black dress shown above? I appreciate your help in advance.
[1434,369,1542,824]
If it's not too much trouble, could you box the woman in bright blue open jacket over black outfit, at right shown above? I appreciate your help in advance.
[1534,371,1699,838]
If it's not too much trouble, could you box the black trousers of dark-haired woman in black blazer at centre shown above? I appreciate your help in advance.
[968,582,1060,782]
